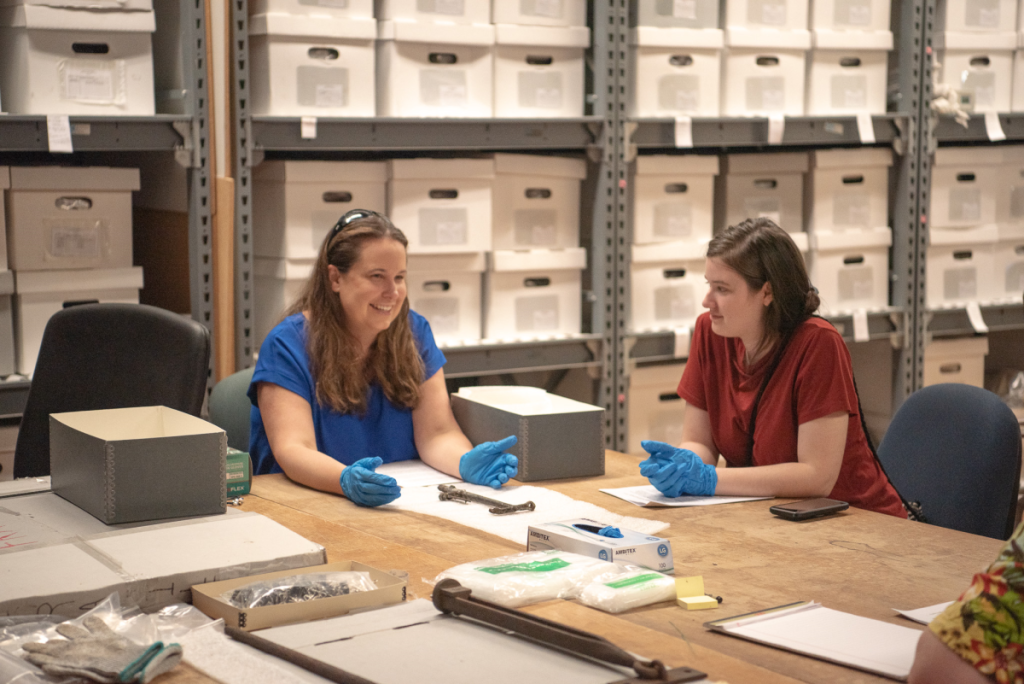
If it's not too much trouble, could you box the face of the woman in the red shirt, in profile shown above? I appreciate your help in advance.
[702,257,772,350]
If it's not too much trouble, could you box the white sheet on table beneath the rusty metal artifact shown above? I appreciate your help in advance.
[385,482,669,544]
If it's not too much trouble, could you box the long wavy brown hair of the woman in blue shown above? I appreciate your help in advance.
[286,211,424,415]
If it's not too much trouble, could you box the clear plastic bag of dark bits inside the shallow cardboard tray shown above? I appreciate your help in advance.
[220,570,377,608]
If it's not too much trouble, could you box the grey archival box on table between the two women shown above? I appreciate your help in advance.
[452,386,604,482]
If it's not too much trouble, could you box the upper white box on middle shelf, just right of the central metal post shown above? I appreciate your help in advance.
[633,155,718,245]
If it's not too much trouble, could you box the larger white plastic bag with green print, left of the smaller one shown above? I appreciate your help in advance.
[436,550,608,608]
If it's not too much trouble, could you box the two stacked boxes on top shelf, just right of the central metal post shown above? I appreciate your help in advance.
[630,0,723,117]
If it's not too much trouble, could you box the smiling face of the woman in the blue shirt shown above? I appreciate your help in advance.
[328,238,407,350]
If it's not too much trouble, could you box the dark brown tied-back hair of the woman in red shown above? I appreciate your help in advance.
[708,218,821,358]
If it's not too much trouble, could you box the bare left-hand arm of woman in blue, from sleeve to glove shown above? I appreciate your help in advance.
[256,382,345,495]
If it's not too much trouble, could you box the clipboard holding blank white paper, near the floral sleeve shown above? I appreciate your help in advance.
[703,601,921,682]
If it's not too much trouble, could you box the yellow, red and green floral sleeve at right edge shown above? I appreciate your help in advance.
[928,523,1024,684]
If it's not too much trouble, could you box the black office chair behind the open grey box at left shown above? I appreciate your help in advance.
[14,304,210,477]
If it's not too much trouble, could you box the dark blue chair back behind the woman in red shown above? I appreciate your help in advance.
[879,383,1021,540]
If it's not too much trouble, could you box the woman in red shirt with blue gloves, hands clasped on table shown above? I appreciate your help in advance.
[640,218,906,518]
